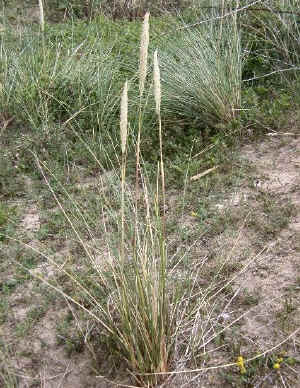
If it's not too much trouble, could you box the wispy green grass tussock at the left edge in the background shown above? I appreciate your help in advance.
[2,35,118,130]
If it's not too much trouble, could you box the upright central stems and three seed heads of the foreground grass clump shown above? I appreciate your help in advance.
[112,13,176,386]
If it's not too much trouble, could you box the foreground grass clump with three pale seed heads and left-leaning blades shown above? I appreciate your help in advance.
[30,14,178,386]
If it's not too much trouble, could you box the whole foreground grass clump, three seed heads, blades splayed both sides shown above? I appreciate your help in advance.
[19,14,253,386]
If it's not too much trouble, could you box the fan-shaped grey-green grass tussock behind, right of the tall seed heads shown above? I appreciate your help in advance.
[161,9,244,126]
